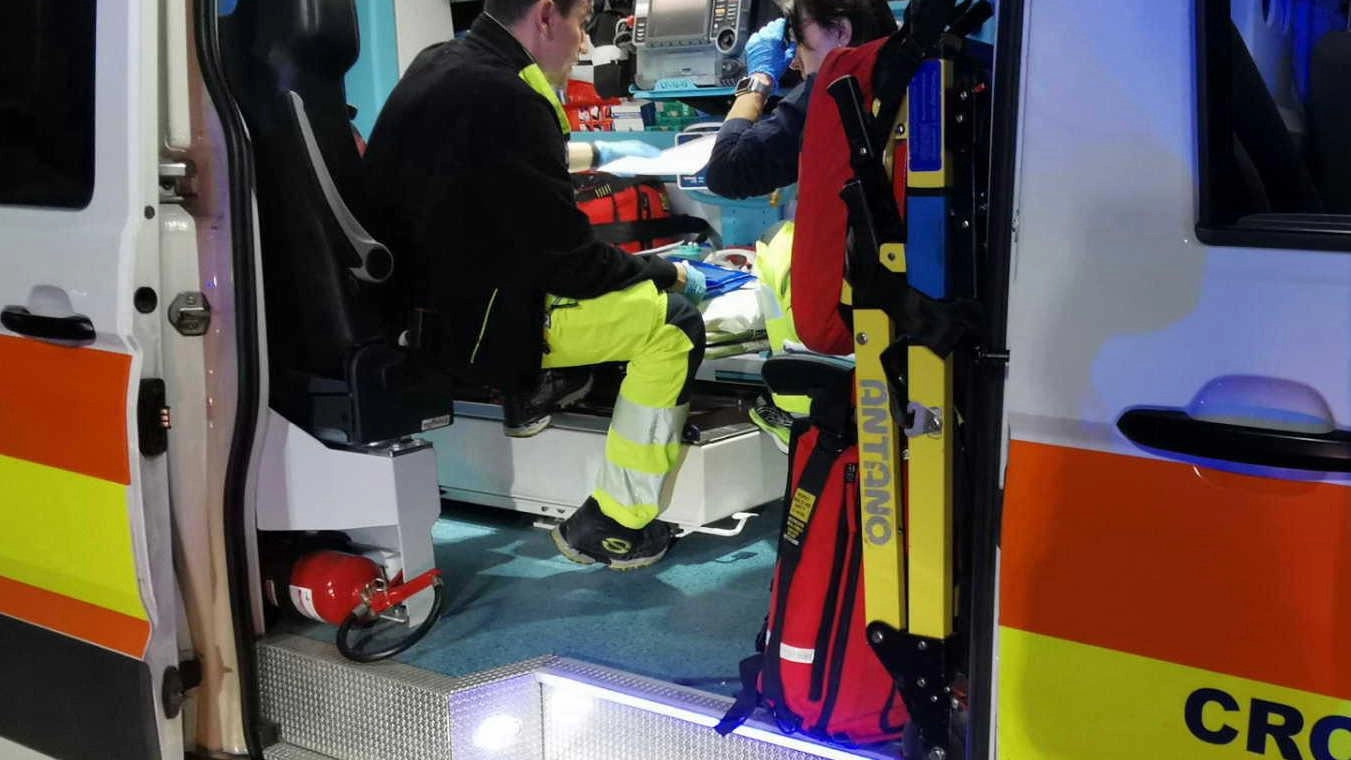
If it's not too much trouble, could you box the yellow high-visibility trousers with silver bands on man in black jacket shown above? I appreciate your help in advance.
[543,281,704,528]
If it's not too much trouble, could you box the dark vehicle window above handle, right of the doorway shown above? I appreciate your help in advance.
[1197,0,1351,251]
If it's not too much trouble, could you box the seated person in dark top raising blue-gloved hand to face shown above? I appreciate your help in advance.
[705,0,896,454]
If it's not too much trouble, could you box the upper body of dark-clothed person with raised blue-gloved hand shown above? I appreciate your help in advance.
[705,0,896,198]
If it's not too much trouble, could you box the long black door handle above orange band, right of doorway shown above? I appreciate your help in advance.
[1116,409,1351,472]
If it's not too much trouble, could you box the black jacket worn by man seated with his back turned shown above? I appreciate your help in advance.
[365,15,676,389]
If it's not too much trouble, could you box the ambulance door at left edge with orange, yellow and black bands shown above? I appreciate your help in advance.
[0,0,182,760]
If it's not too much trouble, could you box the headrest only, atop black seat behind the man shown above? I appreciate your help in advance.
[258,0,361,77]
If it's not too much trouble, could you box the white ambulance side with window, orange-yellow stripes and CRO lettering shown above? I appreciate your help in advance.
[996,0,1351,760]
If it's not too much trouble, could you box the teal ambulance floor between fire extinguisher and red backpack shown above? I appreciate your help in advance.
[285,504,780,694]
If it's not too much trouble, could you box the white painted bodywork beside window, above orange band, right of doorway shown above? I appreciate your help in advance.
[1005,0,1351,464]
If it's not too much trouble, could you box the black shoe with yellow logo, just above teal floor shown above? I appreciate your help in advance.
[553,497,674,570]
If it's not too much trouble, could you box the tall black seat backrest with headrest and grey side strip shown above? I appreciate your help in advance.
[222,0,380,380]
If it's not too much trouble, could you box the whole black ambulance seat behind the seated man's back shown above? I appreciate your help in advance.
[220,0,451,444]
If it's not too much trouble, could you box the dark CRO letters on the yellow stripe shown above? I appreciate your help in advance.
[1185,688,1351,760]
